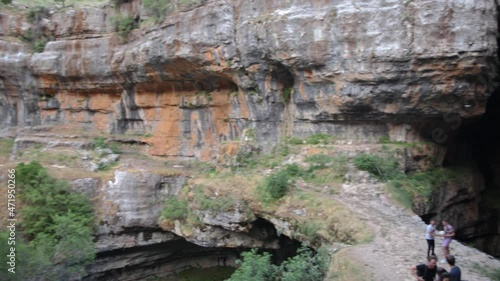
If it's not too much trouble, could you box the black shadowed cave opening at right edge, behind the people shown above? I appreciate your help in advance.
[443,89,500,257]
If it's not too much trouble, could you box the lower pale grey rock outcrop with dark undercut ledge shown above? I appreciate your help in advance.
[78,167,299,280]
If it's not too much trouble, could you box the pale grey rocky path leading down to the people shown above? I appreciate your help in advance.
[330,179,500,281]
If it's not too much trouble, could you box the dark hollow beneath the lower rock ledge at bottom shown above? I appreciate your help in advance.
[88,218,301,281]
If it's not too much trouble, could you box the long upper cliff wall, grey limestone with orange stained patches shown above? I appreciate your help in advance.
[0,0,497,160]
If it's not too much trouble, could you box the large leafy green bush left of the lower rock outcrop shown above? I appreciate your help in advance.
[16,162,95,280]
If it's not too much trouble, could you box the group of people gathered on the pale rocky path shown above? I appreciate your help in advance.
[410,220,462,281]
